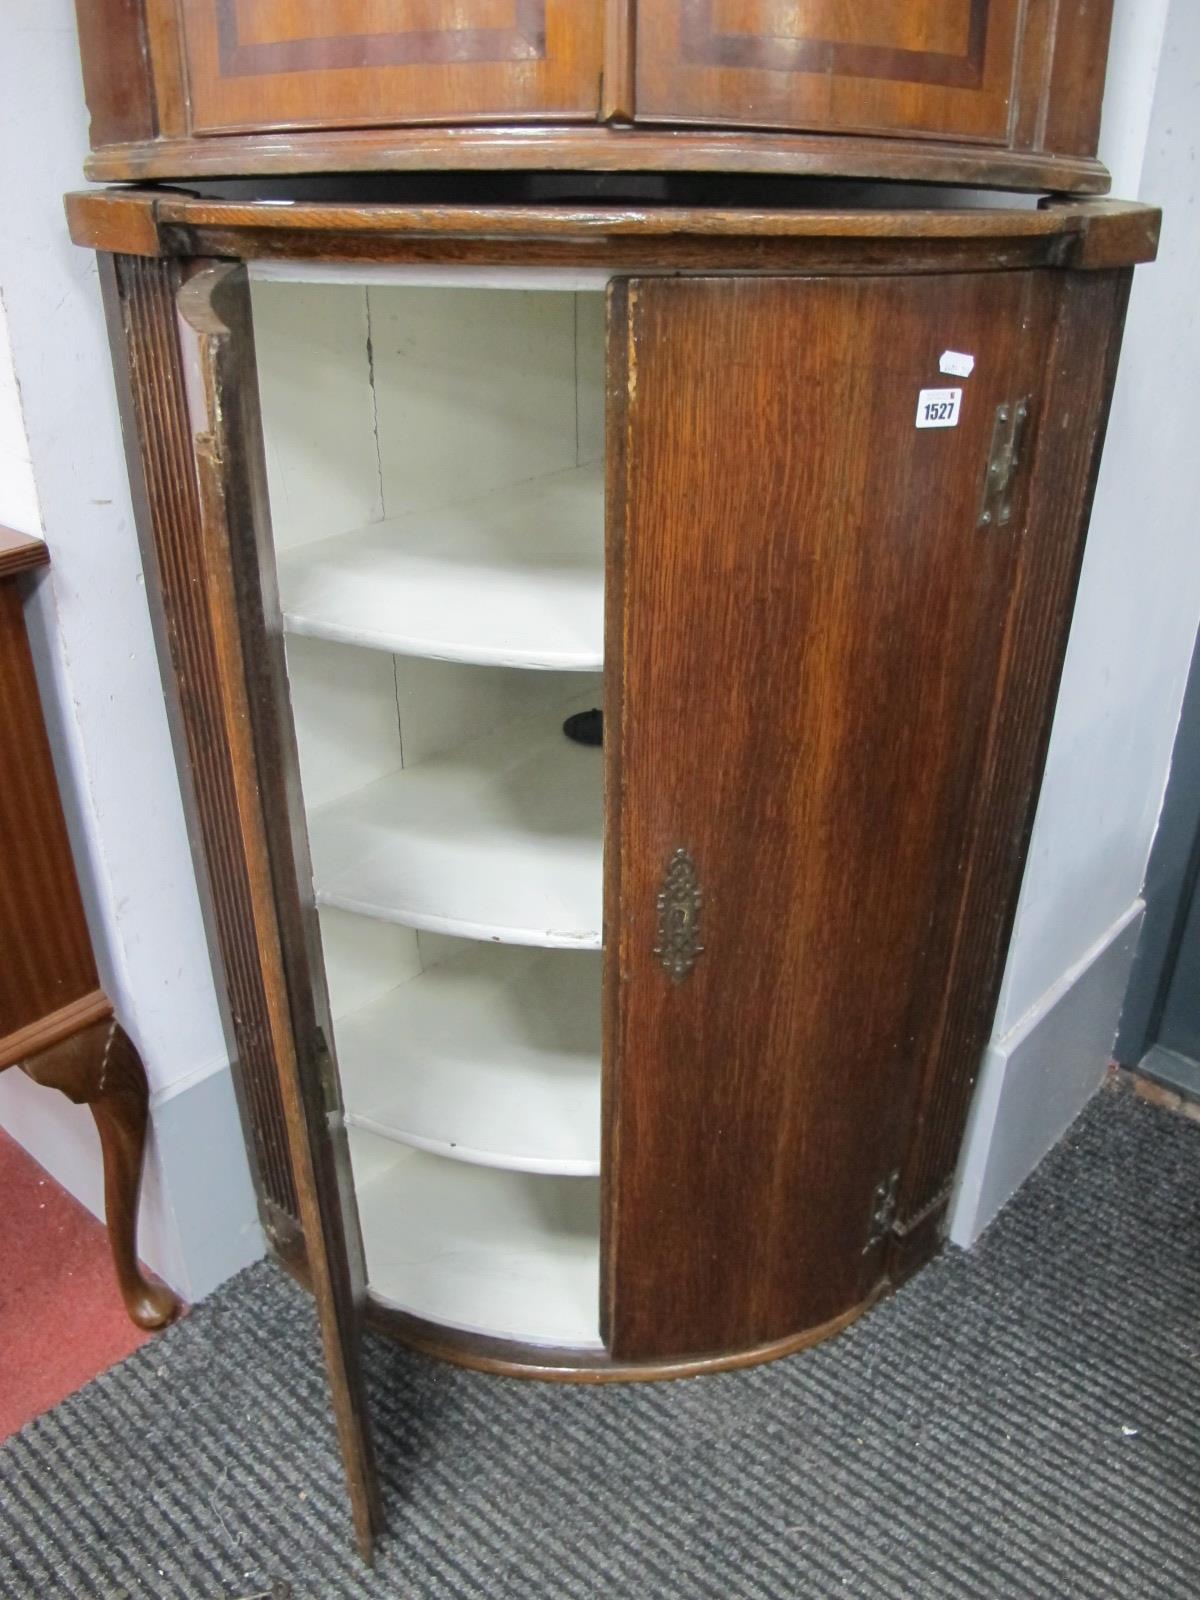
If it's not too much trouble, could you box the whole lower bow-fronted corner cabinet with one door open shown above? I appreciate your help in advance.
[69,190,1158,1544]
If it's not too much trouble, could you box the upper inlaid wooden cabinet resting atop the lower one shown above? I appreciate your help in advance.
[77,0,1112,194]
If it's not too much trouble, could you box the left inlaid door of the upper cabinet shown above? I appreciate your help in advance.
[181,0,603,133]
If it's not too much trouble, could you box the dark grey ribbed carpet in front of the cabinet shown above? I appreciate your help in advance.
[0,1091,1200,1600]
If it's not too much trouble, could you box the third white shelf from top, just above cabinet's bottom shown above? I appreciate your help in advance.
[336,946,600,1178]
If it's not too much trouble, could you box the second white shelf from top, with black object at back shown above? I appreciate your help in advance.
[309,696,603,950]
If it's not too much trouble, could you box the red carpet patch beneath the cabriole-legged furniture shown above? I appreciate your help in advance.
[0,1130,149,1438]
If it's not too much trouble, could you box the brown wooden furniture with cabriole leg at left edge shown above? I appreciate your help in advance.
[0,528,179,1328]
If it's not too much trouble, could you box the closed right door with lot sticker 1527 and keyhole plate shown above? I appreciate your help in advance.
[605,274,1053,1358]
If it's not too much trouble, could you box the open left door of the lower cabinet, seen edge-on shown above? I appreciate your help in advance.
[169,258,382,1560]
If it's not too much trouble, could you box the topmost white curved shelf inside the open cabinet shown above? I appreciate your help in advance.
[278,464,605,670]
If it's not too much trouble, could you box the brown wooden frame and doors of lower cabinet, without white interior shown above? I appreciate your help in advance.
[72,206,1158,1580]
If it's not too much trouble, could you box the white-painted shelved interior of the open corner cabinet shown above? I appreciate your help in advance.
[253,270,605,1344]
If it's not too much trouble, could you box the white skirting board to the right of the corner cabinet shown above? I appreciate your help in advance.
[949,901,1146,1248]
